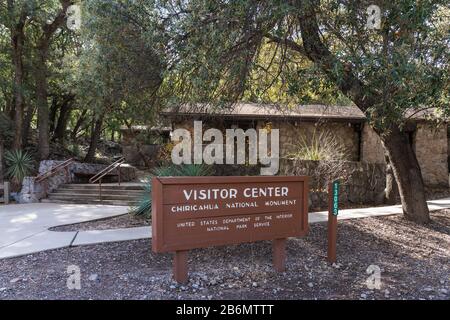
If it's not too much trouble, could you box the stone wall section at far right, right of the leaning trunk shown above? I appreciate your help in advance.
[414,123,448,187]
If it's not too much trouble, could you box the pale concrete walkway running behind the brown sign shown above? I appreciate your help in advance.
[0,198,450,259]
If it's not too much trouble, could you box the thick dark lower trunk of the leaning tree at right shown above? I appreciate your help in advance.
[381,127,430,223]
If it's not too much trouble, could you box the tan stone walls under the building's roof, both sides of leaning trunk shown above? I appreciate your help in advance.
[173,120,450,187]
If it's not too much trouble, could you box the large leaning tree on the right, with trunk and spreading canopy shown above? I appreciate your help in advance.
[150,0,450,222]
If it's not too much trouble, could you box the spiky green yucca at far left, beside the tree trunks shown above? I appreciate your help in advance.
[4,150,33,183]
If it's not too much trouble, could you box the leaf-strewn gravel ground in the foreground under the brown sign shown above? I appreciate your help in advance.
[0,210,450,300]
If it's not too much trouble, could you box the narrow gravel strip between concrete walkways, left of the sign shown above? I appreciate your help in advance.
[50,213,151,231]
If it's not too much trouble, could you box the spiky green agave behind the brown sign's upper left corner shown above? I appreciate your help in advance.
[132,164,213,218]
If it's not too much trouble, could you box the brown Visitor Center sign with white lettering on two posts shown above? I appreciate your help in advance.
[152,176,308,282]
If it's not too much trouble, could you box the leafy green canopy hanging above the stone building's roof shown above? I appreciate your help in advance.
[153,0,450,128]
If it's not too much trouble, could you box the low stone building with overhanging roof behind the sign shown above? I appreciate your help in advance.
[162,103,449,187]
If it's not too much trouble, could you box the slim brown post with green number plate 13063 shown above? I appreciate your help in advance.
[328,180,339,263]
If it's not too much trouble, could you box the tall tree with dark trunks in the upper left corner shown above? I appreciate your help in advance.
[0,0,75,154]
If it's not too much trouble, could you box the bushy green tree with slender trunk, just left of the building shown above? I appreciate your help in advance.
[76,0,164,161]
